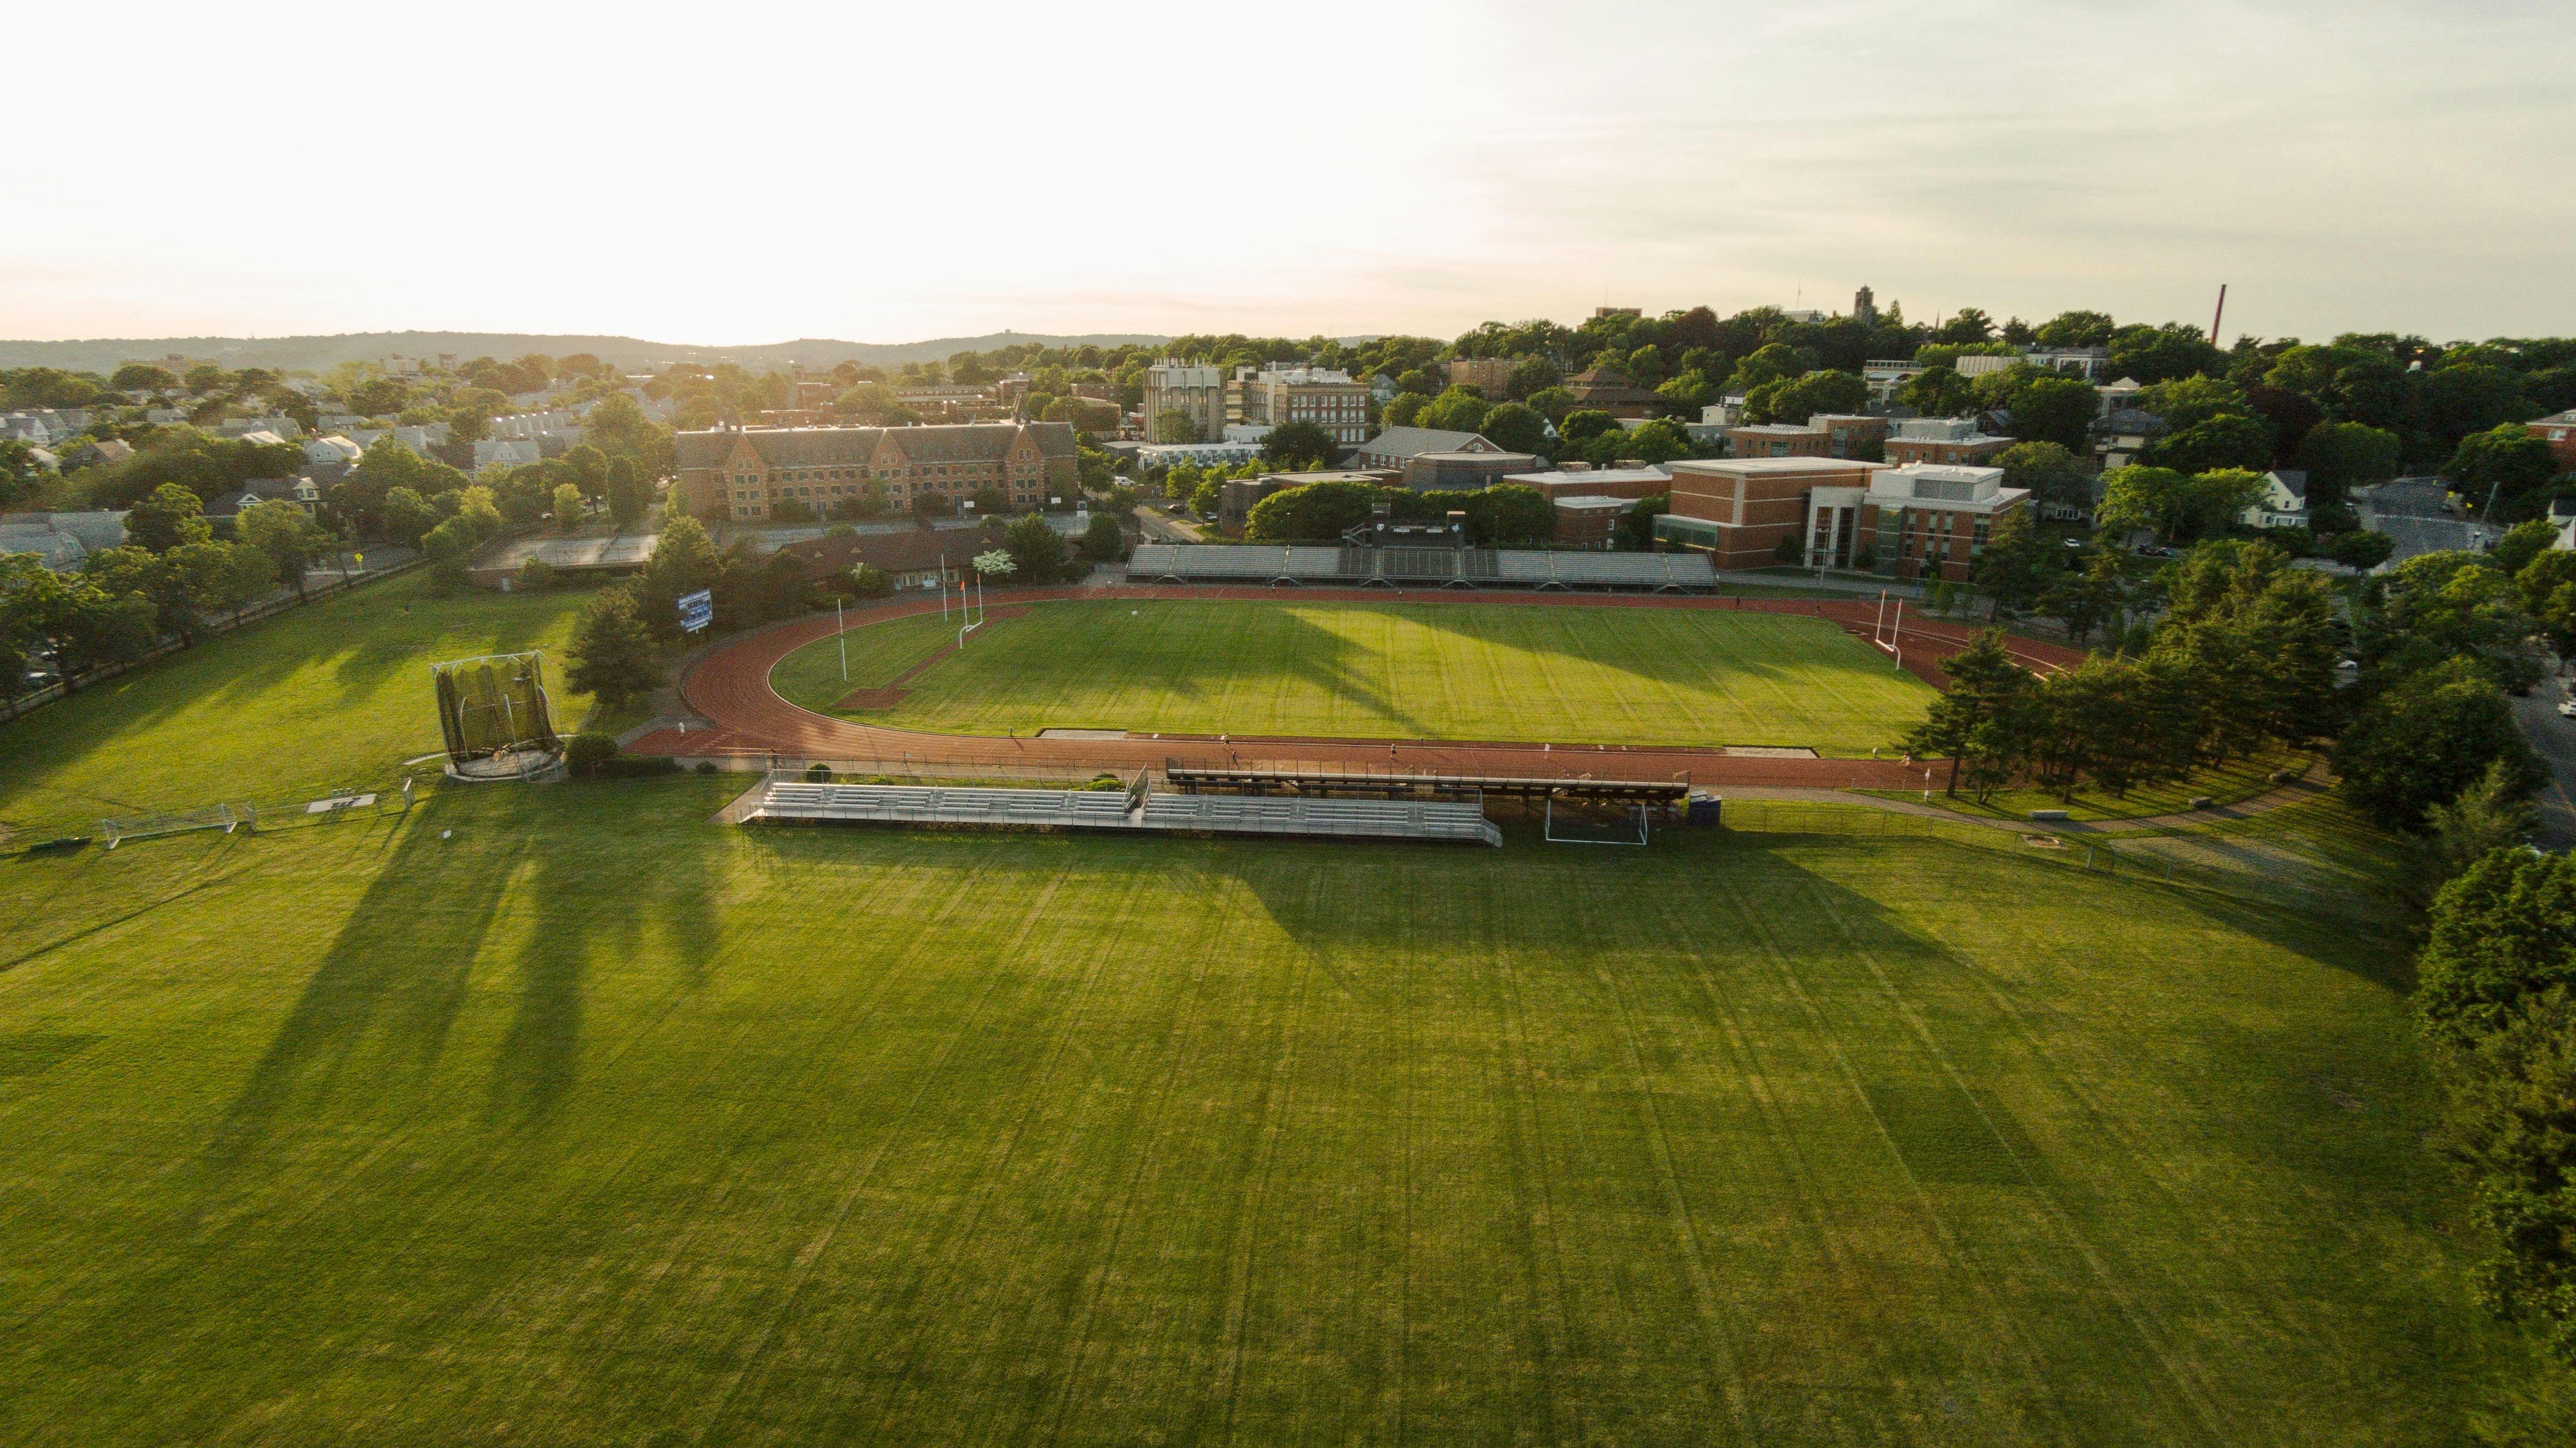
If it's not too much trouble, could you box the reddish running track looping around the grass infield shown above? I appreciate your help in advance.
[631,588,2084,789]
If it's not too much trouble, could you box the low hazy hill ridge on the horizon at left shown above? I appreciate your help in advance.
[0,333,1169,371]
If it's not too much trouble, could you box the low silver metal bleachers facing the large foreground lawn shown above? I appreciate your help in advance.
[744,780,1502,845]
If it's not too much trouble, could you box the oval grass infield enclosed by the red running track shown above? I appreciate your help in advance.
[770,603,1932,755]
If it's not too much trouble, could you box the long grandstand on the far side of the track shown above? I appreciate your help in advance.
[1126,544,1718,592]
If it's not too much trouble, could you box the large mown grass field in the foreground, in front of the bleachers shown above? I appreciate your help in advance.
[0,778,2514,1446]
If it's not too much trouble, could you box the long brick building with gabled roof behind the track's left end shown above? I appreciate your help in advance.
[675,423,1079,523]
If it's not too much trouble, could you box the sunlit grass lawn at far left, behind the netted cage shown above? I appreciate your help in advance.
[0,564,590,837]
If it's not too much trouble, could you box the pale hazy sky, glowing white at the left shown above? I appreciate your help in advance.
[0,0,2576,346]
